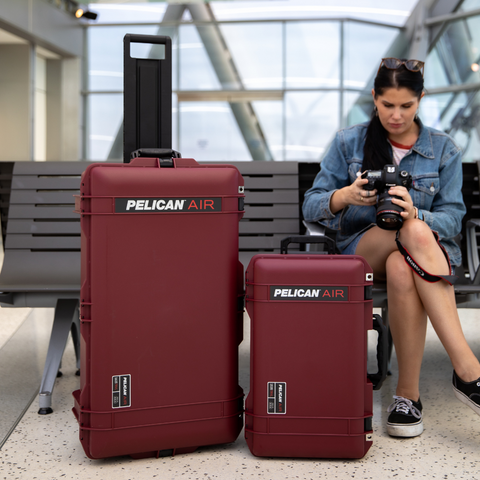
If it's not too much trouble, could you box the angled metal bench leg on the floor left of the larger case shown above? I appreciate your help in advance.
[38,299,80,415]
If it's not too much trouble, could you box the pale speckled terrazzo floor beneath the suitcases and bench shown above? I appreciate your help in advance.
[0,309,480,480]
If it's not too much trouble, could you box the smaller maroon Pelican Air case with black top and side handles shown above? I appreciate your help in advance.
[245,237,387,458]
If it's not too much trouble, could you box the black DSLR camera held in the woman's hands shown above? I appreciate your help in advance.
[362,165,412,230]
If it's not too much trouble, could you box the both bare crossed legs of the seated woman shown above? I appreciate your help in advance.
[356,220,480,394]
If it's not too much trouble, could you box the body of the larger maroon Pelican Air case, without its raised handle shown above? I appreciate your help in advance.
[73,158,244,458]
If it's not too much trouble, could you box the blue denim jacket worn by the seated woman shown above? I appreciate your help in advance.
[303,121,466,265]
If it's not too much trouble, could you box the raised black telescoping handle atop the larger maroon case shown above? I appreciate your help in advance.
[123,34,172,163]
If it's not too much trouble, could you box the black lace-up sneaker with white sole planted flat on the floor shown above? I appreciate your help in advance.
[387,395,423,437]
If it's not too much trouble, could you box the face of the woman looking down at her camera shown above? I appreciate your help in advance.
[372,87,423,143]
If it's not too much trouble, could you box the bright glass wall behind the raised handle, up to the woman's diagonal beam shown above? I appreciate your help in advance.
[84,0,404,161]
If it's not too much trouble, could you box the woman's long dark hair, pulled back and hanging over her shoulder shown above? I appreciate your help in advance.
[362,65,423,171]
